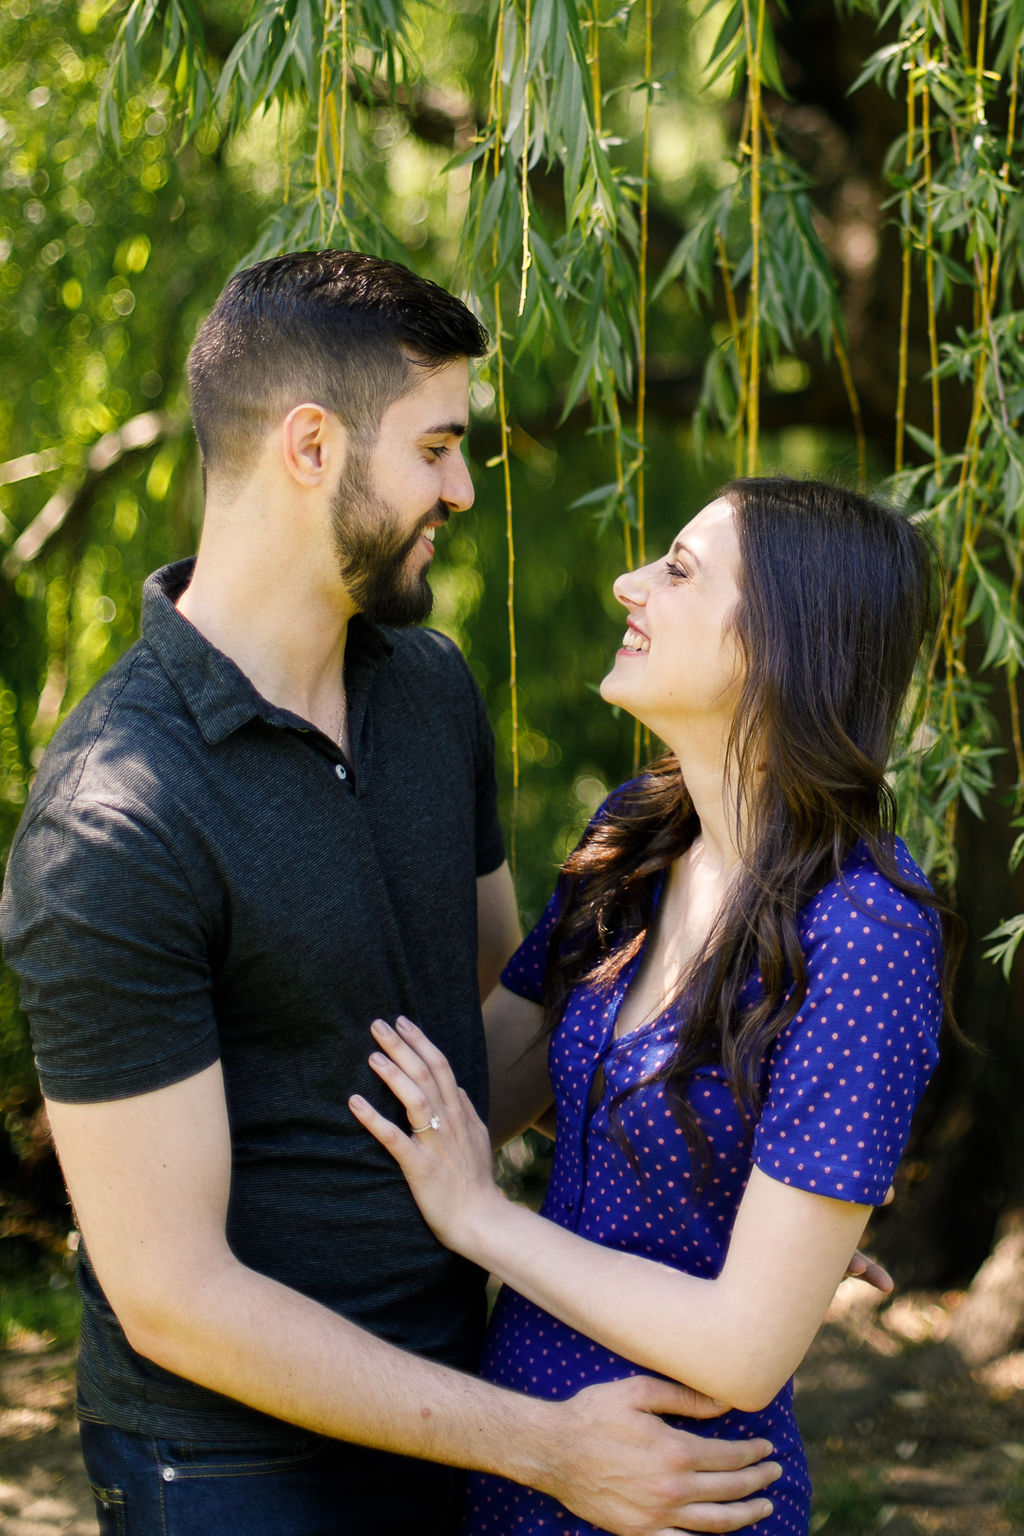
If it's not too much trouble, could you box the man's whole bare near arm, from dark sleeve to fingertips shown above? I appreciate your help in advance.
[48,1064,775,1536]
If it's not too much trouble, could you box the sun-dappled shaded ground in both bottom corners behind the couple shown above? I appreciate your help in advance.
[0,1283,1024,1536]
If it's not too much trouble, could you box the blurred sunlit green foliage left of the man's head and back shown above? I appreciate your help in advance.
[0,0,267,1185]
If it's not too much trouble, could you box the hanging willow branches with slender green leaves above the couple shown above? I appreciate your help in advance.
[92,0,1024,958]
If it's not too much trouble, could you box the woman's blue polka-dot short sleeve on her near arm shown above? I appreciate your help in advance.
[752,863,943,1206]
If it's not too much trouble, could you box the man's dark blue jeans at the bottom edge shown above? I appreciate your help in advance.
[80,1419,462,1536]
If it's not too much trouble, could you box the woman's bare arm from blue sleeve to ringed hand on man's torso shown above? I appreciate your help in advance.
[352,1020,869,1410]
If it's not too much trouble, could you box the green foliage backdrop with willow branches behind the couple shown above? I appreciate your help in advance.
[0,0,1024,1275]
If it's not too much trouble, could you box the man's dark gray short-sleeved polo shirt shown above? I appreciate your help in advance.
[3,562,504,1439]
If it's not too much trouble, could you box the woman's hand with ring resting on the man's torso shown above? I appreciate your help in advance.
[348,1018,505,1253]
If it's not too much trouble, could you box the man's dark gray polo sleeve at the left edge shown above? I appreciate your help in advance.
[3,799,220,1103]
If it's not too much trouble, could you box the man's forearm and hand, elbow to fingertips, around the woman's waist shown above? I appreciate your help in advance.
[130,1263,778,1536]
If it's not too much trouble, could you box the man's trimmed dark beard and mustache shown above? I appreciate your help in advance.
[332,452,448,625]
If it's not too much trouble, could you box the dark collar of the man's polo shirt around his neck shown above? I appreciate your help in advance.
[143,559,395,746]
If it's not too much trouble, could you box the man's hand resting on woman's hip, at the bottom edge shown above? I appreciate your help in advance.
[537,1376,781,1536]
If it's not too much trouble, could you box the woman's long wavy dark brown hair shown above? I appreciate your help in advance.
[545,478,963,1169]
